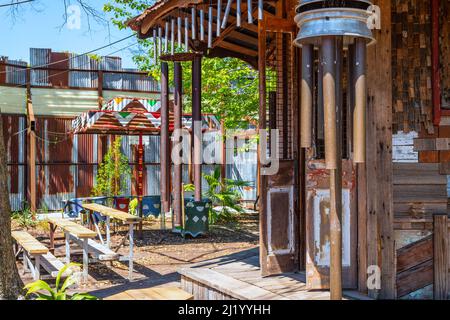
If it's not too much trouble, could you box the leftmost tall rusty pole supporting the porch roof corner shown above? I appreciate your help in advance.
[160,62,170,214]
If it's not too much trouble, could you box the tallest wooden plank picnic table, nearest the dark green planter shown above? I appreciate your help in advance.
[81,203,141,280]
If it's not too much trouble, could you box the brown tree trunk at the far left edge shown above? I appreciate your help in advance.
[0,112,23,300]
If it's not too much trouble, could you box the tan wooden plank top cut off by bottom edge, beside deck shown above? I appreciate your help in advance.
[104,287,194,300]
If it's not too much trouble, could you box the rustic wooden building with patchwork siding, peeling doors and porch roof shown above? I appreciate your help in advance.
[128,0,450,299]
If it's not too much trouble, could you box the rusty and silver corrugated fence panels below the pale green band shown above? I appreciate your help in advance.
[2,115,256,210]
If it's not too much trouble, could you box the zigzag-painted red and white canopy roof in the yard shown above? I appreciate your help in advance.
[72,97,220,135]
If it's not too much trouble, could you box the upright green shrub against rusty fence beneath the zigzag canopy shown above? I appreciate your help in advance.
[92,138,131,197]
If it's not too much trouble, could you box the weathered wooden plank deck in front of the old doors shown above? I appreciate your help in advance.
[178,249,368,300]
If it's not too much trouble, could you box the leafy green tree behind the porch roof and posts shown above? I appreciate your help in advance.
[103,0,259,128]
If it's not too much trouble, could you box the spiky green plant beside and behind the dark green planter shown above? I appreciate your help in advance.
[203,167,251,224]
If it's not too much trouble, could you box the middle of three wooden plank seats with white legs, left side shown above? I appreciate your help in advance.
[48,218,97,282]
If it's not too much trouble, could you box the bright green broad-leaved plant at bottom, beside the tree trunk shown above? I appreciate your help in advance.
[24,263,98,300]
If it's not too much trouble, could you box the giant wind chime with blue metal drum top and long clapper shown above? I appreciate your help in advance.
[294,0,374,300]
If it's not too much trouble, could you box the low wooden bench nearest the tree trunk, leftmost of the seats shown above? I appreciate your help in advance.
[12,231,70,280]
